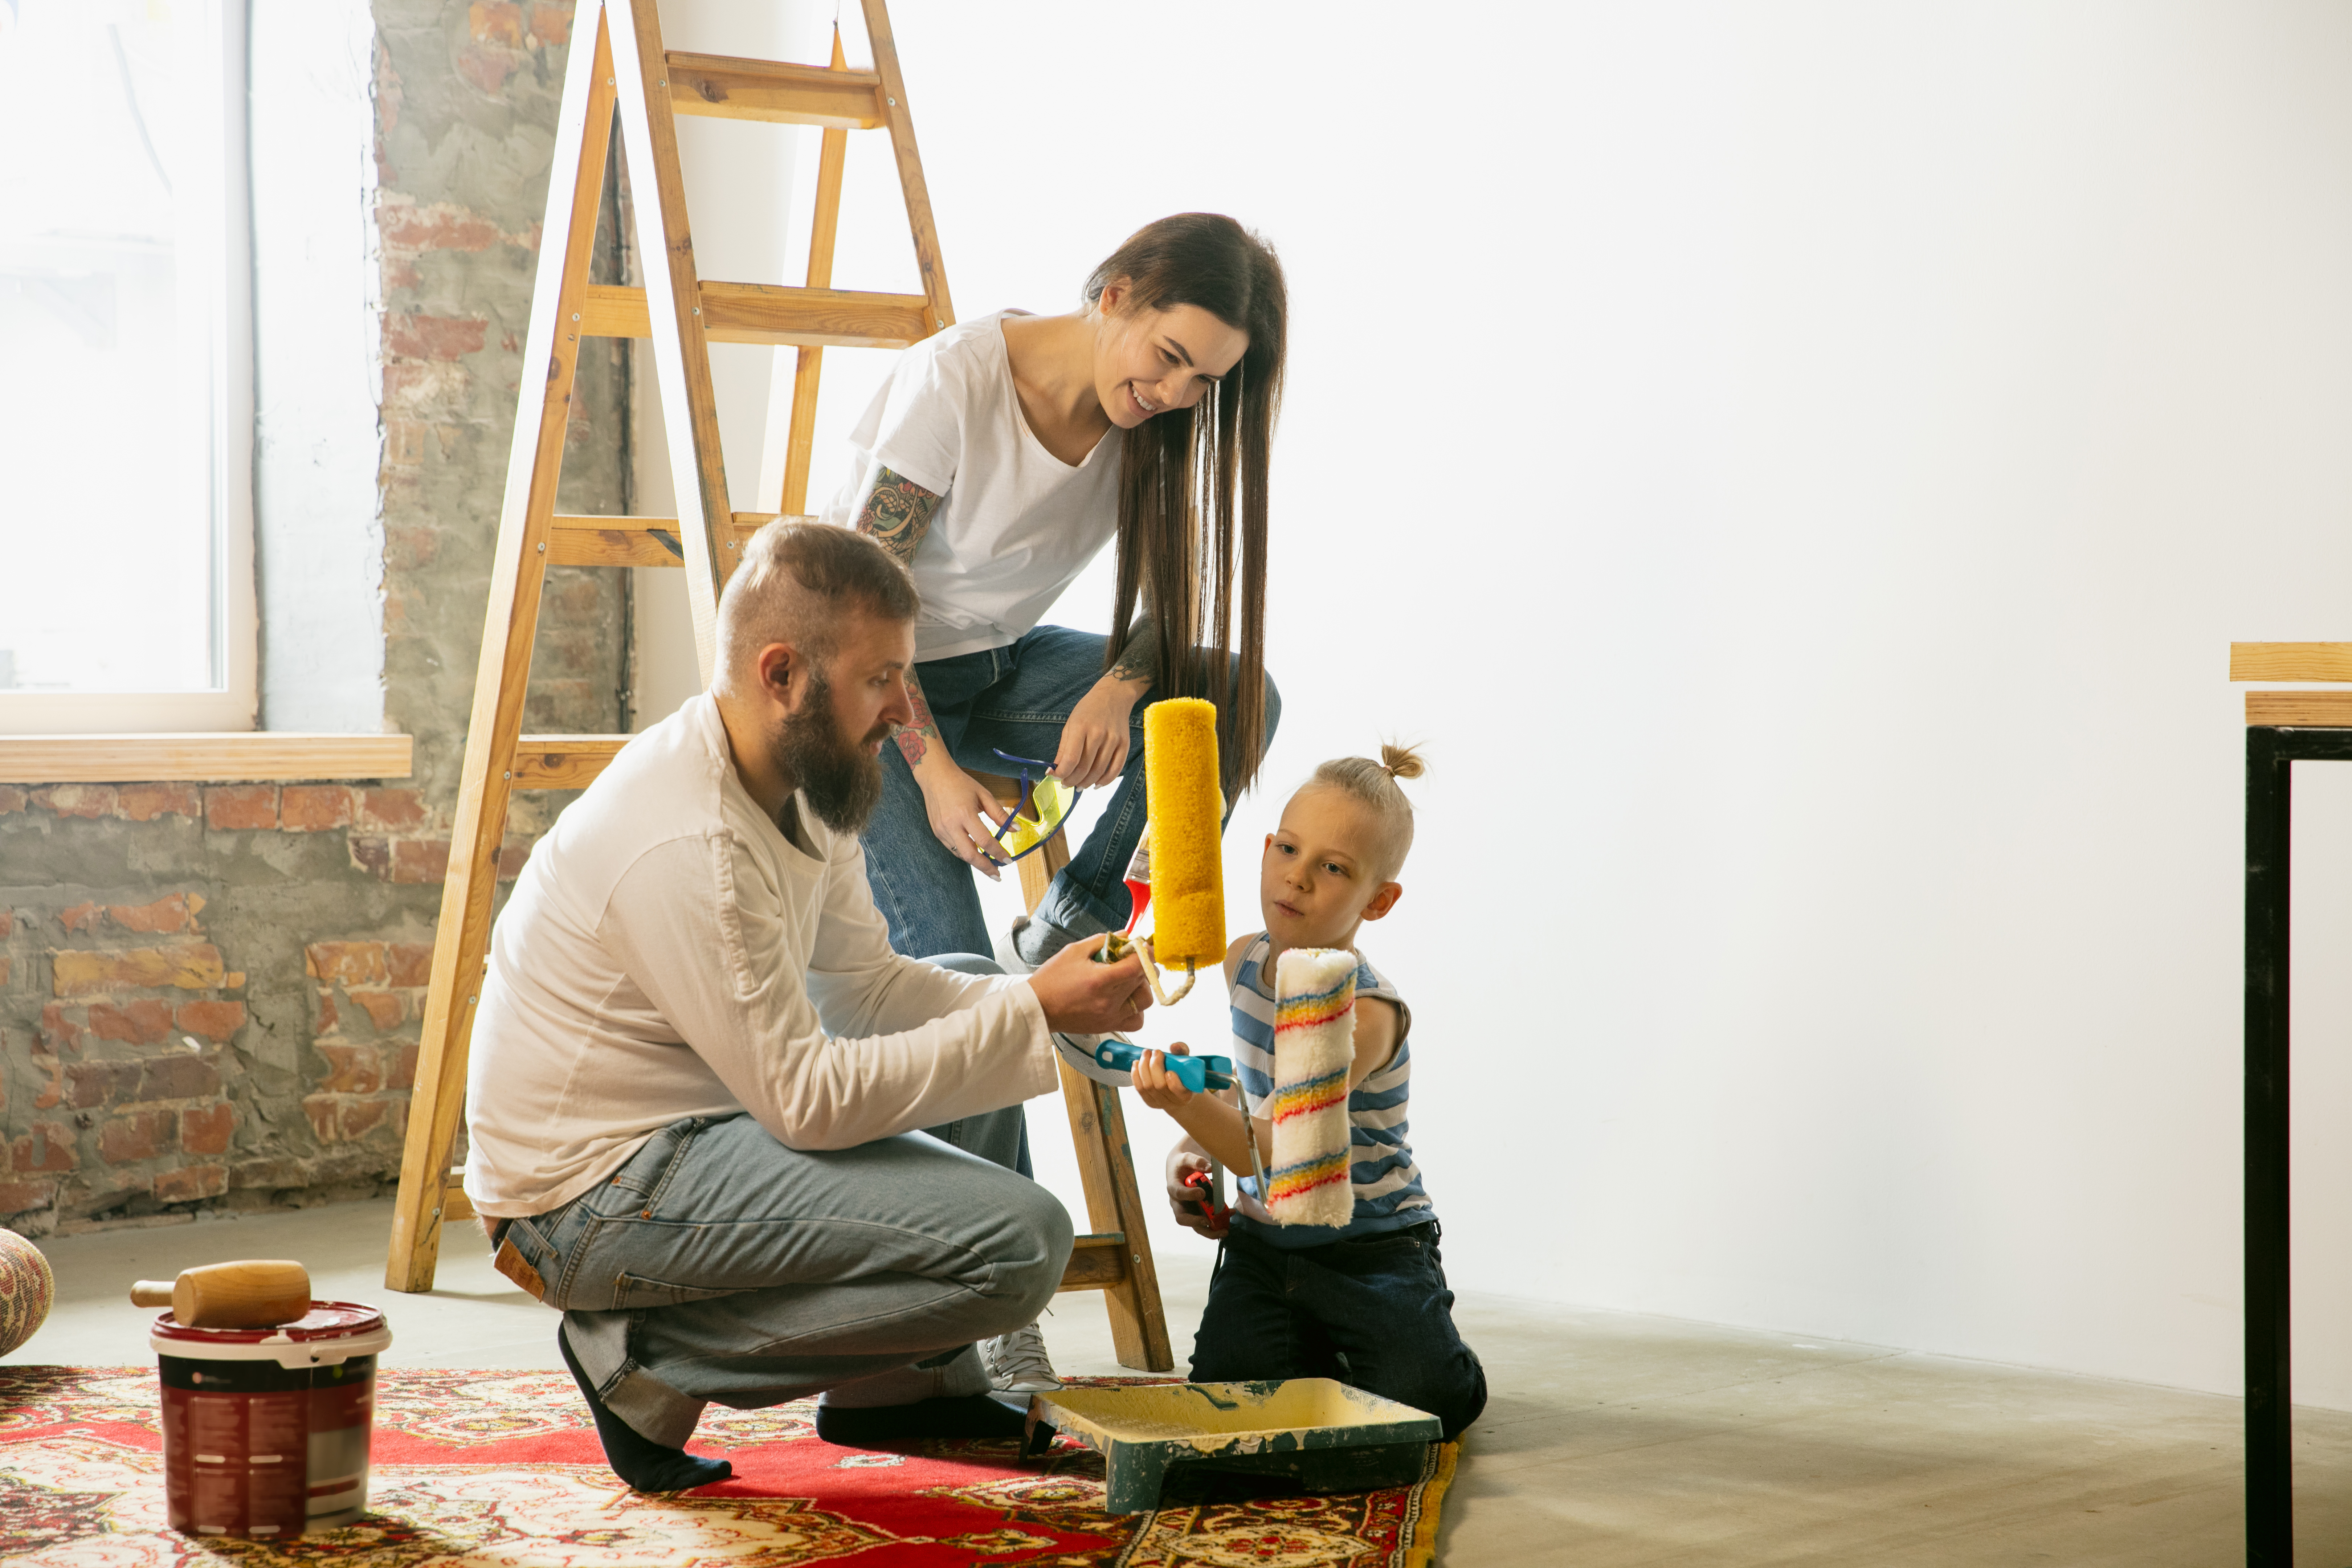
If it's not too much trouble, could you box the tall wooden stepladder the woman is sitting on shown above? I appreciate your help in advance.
[383,0,1174,1371]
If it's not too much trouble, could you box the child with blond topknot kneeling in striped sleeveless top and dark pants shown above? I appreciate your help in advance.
[1134,745,1486,1439]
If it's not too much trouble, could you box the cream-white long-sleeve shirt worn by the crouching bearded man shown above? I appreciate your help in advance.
[466,694,1056,1218]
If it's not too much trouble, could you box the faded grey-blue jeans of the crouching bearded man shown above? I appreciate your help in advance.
[506,955,1070,1448]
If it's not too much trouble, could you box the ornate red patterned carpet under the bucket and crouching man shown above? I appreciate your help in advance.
[0,1366,1454,1568]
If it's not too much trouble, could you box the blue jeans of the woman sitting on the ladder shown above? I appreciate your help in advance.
[863,625,1282,959]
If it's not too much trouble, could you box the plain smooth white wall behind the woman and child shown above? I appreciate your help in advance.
[621,0,2352,1406]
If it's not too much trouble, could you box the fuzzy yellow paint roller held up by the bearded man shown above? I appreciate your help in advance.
[1096,696,1225,1004]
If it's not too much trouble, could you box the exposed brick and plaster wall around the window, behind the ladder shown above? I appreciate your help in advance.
[0,0,628,1234]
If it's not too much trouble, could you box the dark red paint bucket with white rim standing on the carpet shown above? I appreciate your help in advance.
[148,1300,393,1540]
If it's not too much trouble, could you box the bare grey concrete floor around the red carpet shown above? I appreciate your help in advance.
[7,1204,2352,1568]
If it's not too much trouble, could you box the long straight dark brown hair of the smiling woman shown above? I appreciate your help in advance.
[1087,212,1287,799]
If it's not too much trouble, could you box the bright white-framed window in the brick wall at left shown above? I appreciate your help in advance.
[0,0,254,734]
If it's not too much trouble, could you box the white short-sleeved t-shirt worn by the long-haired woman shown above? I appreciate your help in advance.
[823,310,1119,661]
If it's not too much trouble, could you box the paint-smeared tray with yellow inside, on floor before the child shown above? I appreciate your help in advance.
[1025,1377,1442,1514]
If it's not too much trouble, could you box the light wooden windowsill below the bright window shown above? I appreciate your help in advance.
[0,731,416,785]
